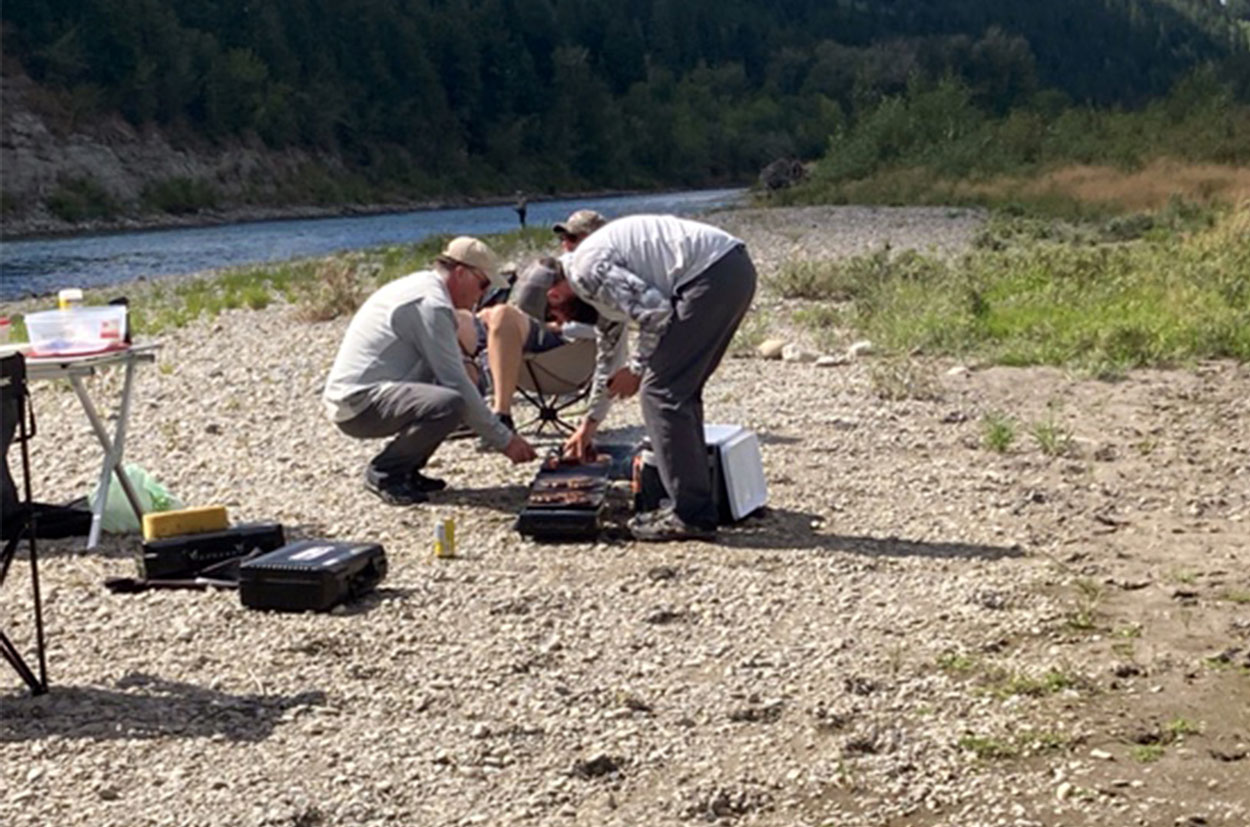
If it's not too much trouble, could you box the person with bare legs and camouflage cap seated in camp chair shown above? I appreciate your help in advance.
[460,210,608,430]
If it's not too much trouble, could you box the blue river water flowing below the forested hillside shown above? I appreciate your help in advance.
[0,190,745,300]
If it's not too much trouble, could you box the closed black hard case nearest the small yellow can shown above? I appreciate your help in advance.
[239,540,386,612]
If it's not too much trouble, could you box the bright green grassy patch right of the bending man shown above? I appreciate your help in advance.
[771,201,1250,375]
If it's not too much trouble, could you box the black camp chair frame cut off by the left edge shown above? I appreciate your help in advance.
[0,354,48,695]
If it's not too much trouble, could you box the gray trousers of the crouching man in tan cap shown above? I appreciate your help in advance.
[338,382,465,485]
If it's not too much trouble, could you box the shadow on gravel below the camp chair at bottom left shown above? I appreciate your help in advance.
[0,672,326,743]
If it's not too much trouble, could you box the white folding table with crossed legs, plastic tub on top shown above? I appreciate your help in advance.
[3,342,160,548]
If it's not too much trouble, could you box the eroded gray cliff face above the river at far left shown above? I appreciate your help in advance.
[0,74,343,236]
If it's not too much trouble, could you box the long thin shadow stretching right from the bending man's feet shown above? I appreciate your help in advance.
[718,508,1025,560]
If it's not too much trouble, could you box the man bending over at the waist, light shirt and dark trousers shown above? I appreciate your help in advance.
[548,215,756,540]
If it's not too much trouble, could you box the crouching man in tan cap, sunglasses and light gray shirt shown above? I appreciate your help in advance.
[323,236,535,505]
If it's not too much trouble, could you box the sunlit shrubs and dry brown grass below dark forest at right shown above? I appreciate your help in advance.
[769,70,1250,219]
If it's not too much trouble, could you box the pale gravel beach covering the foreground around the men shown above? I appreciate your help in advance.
[0,207,1250,827]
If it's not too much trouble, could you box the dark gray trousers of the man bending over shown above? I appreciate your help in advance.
[641,247,756,528]
